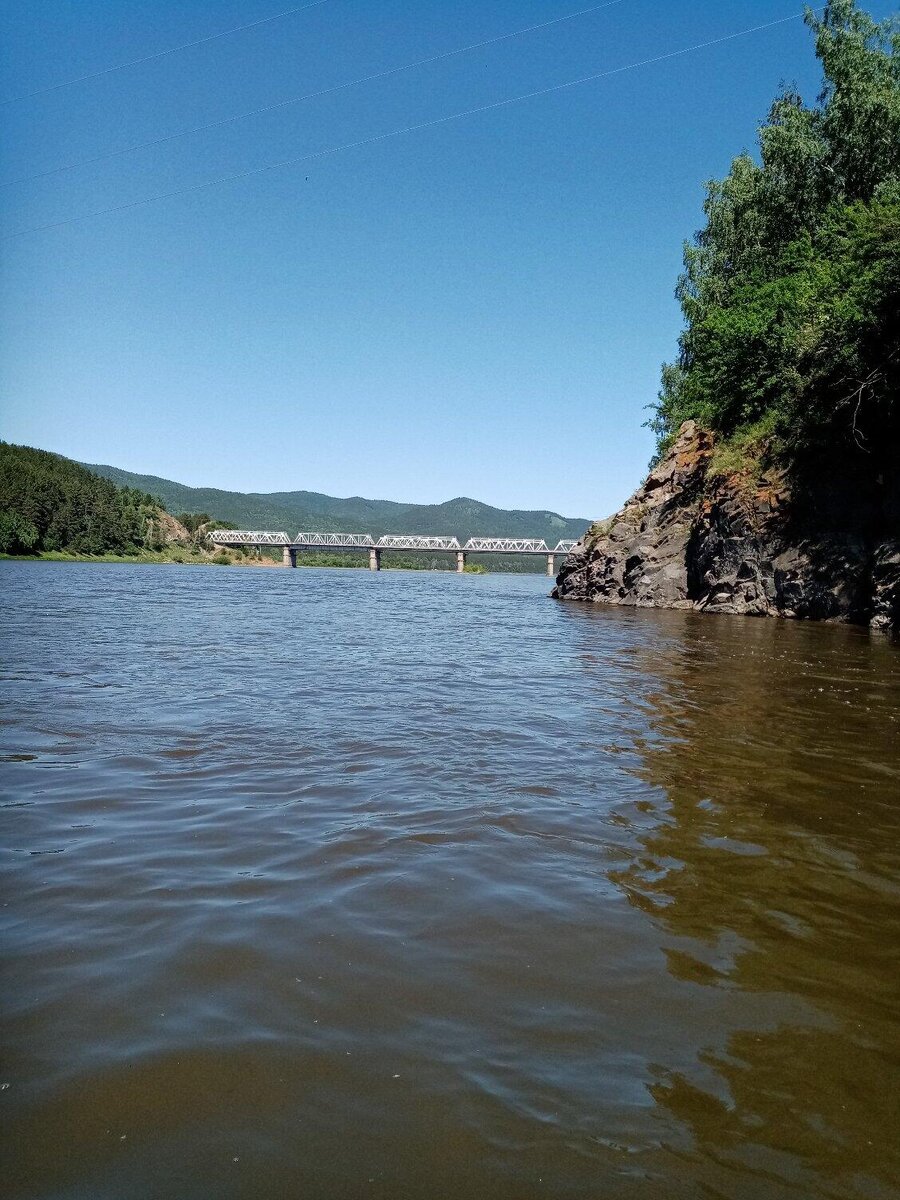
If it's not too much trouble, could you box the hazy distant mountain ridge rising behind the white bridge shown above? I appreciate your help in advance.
[82,463,590,545]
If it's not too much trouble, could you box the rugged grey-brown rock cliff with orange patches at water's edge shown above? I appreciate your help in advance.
[553,421,900,629]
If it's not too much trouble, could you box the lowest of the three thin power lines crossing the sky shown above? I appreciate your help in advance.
[0,12,804,241]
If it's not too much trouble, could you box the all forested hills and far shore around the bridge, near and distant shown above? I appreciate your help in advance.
[0,442,588,572]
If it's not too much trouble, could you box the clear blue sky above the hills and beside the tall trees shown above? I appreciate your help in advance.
[0,0,893,517]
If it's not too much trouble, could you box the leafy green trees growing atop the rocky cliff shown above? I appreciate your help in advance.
[650,0,900,457]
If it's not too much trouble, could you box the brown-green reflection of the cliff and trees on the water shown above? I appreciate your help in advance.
[566,611,900,1196]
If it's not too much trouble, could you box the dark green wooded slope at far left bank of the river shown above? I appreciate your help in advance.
[0,442,168,554]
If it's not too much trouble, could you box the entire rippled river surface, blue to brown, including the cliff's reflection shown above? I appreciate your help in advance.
[0,563,900,1200]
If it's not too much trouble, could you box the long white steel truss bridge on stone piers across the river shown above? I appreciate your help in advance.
[206,529,575,575]
